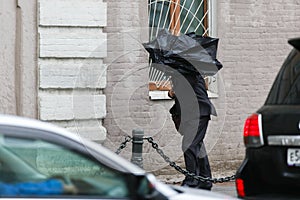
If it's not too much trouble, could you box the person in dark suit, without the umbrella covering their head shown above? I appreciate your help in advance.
[169,69,216,190]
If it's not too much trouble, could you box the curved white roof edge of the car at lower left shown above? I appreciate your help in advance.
[0,114,145,174]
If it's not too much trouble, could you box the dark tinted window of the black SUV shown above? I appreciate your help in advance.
[265,49,300,105]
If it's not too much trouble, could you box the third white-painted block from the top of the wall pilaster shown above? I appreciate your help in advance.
[39,58,107,89]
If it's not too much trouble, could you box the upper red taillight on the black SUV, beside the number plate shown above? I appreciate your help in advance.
[244,114,264,147]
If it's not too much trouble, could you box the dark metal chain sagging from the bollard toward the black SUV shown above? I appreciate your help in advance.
[144,137,235,183]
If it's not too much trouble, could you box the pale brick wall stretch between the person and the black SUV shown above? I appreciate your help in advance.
[209,0,300,177]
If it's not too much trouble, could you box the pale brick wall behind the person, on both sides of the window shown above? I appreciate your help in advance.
[104,0,300,180]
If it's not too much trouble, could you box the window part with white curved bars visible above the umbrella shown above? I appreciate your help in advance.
[149,0,208,40]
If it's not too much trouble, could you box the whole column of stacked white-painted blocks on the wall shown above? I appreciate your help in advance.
[38,0,107,141]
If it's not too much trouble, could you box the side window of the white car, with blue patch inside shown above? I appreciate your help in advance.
[0,136,129,198]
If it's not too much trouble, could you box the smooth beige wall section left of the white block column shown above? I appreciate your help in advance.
[0,0,37,118]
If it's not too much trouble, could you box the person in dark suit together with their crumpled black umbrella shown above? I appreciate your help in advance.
[143,30,222,190]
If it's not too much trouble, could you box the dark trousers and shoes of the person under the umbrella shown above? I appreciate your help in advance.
[183,116,212,189]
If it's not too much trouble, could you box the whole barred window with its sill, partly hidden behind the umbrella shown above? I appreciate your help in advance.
[148,0,217,100]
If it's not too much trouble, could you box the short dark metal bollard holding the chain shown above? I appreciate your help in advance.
[131,129,144,168]
